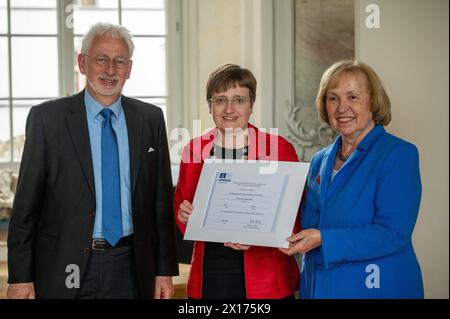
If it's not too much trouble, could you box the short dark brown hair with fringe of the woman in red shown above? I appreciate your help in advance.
[206,64,256,104]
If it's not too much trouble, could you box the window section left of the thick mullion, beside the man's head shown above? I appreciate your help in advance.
[0,0,59,162]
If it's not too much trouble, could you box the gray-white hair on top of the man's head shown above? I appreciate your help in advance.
[81,22,134,57]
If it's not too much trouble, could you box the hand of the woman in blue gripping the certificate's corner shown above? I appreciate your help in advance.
[278,229,322,256]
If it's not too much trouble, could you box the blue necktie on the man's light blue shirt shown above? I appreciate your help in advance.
[101,108,122,246]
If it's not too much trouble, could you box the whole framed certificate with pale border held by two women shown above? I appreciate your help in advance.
[184,159,309,248]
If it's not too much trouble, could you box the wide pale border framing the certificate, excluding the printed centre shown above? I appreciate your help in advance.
[184,159,310,248]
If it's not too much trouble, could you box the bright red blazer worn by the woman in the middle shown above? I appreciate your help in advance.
[174,124,299,299]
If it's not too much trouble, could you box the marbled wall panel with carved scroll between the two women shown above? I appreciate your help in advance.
[274,0,354,161]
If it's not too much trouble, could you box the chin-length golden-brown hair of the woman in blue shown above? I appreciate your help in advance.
[316,60,391,126]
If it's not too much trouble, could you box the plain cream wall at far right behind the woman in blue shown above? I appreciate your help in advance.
[355,0,449,298]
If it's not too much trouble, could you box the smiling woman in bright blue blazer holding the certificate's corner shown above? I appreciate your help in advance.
[280,61,423,298]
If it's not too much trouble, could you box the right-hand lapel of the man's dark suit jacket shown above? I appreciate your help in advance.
[122,95,143,196]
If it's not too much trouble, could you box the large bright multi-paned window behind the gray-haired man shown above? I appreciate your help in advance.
[0,0,181,166]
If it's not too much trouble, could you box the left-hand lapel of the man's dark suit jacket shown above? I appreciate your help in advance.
[66,91,95,197]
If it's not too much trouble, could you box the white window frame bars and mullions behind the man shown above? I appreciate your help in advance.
[0,0,183,172]
